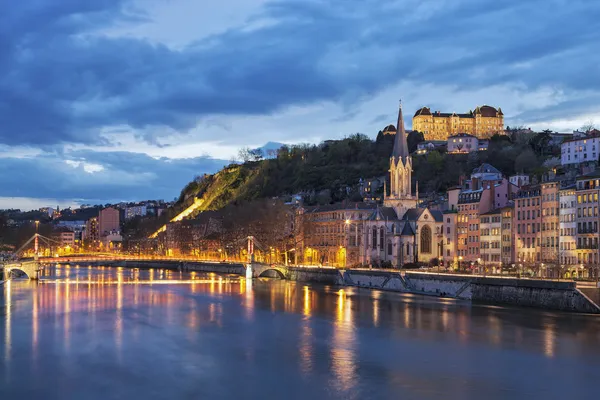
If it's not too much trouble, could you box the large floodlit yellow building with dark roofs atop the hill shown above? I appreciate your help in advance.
[413,105,504,140]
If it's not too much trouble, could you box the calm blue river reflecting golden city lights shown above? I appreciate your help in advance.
[0,267,600,400]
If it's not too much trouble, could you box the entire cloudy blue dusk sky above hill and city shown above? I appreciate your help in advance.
[0,0,600,208]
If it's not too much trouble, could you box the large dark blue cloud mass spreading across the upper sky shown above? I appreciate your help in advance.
[0,0,600,145]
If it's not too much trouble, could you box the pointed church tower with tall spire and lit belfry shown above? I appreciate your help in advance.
[384,103,417,218]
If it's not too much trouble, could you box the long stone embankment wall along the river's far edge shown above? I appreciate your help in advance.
[52,260,600,314]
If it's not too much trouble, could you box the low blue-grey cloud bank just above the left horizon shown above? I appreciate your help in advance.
[0,151,227,203]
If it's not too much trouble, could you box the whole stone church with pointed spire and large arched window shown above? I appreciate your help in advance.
[361,104,444,267]
